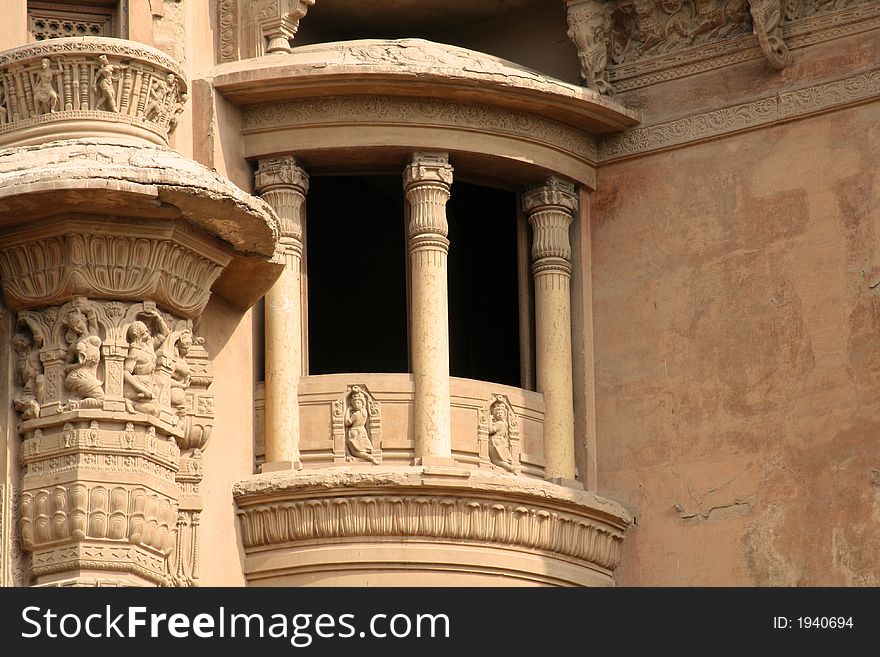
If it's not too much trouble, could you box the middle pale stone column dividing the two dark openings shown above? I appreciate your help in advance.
[403,153,452,465]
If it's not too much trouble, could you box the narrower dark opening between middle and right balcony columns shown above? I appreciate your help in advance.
[447,182,520,387]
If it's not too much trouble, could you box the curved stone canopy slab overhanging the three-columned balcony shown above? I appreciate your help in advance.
[212,39,639,134]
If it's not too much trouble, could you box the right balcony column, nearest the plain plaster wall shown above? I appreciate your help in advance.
[523,177,577,481]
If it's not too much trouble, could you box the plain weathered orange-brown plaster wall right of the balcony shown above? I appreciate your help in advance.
[591,102,880,586]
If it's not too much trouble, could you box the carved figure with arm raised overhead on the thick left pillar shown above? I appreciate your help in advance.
[122,310,168,415]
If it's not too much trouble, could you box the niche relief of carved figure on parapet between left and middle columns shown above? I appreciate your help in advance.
[332,385,382,465]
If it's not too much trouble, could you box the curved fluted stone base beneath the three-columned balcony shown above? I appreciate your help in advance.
[233,467,632,586]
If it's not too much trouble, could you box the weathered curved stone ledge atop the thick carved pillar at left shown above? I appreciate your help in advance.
[0,139,281,308]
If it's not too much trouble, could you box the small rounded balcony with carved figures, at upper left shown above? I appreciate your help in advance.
[0,37,187,147]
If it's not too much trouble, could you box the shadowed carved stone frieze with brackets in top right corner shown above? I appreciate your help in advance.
[567,0,877,95]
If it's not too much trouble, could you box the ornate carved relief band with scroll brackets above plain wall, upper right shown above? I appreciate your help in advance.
[566,0,867,95]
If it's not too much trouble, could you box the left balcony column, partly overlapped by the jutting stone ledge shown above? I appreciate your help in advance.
[256,155,309,470]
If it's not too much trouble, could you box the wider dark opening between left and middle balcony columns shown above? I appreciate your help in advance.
[306,176,408,374]
